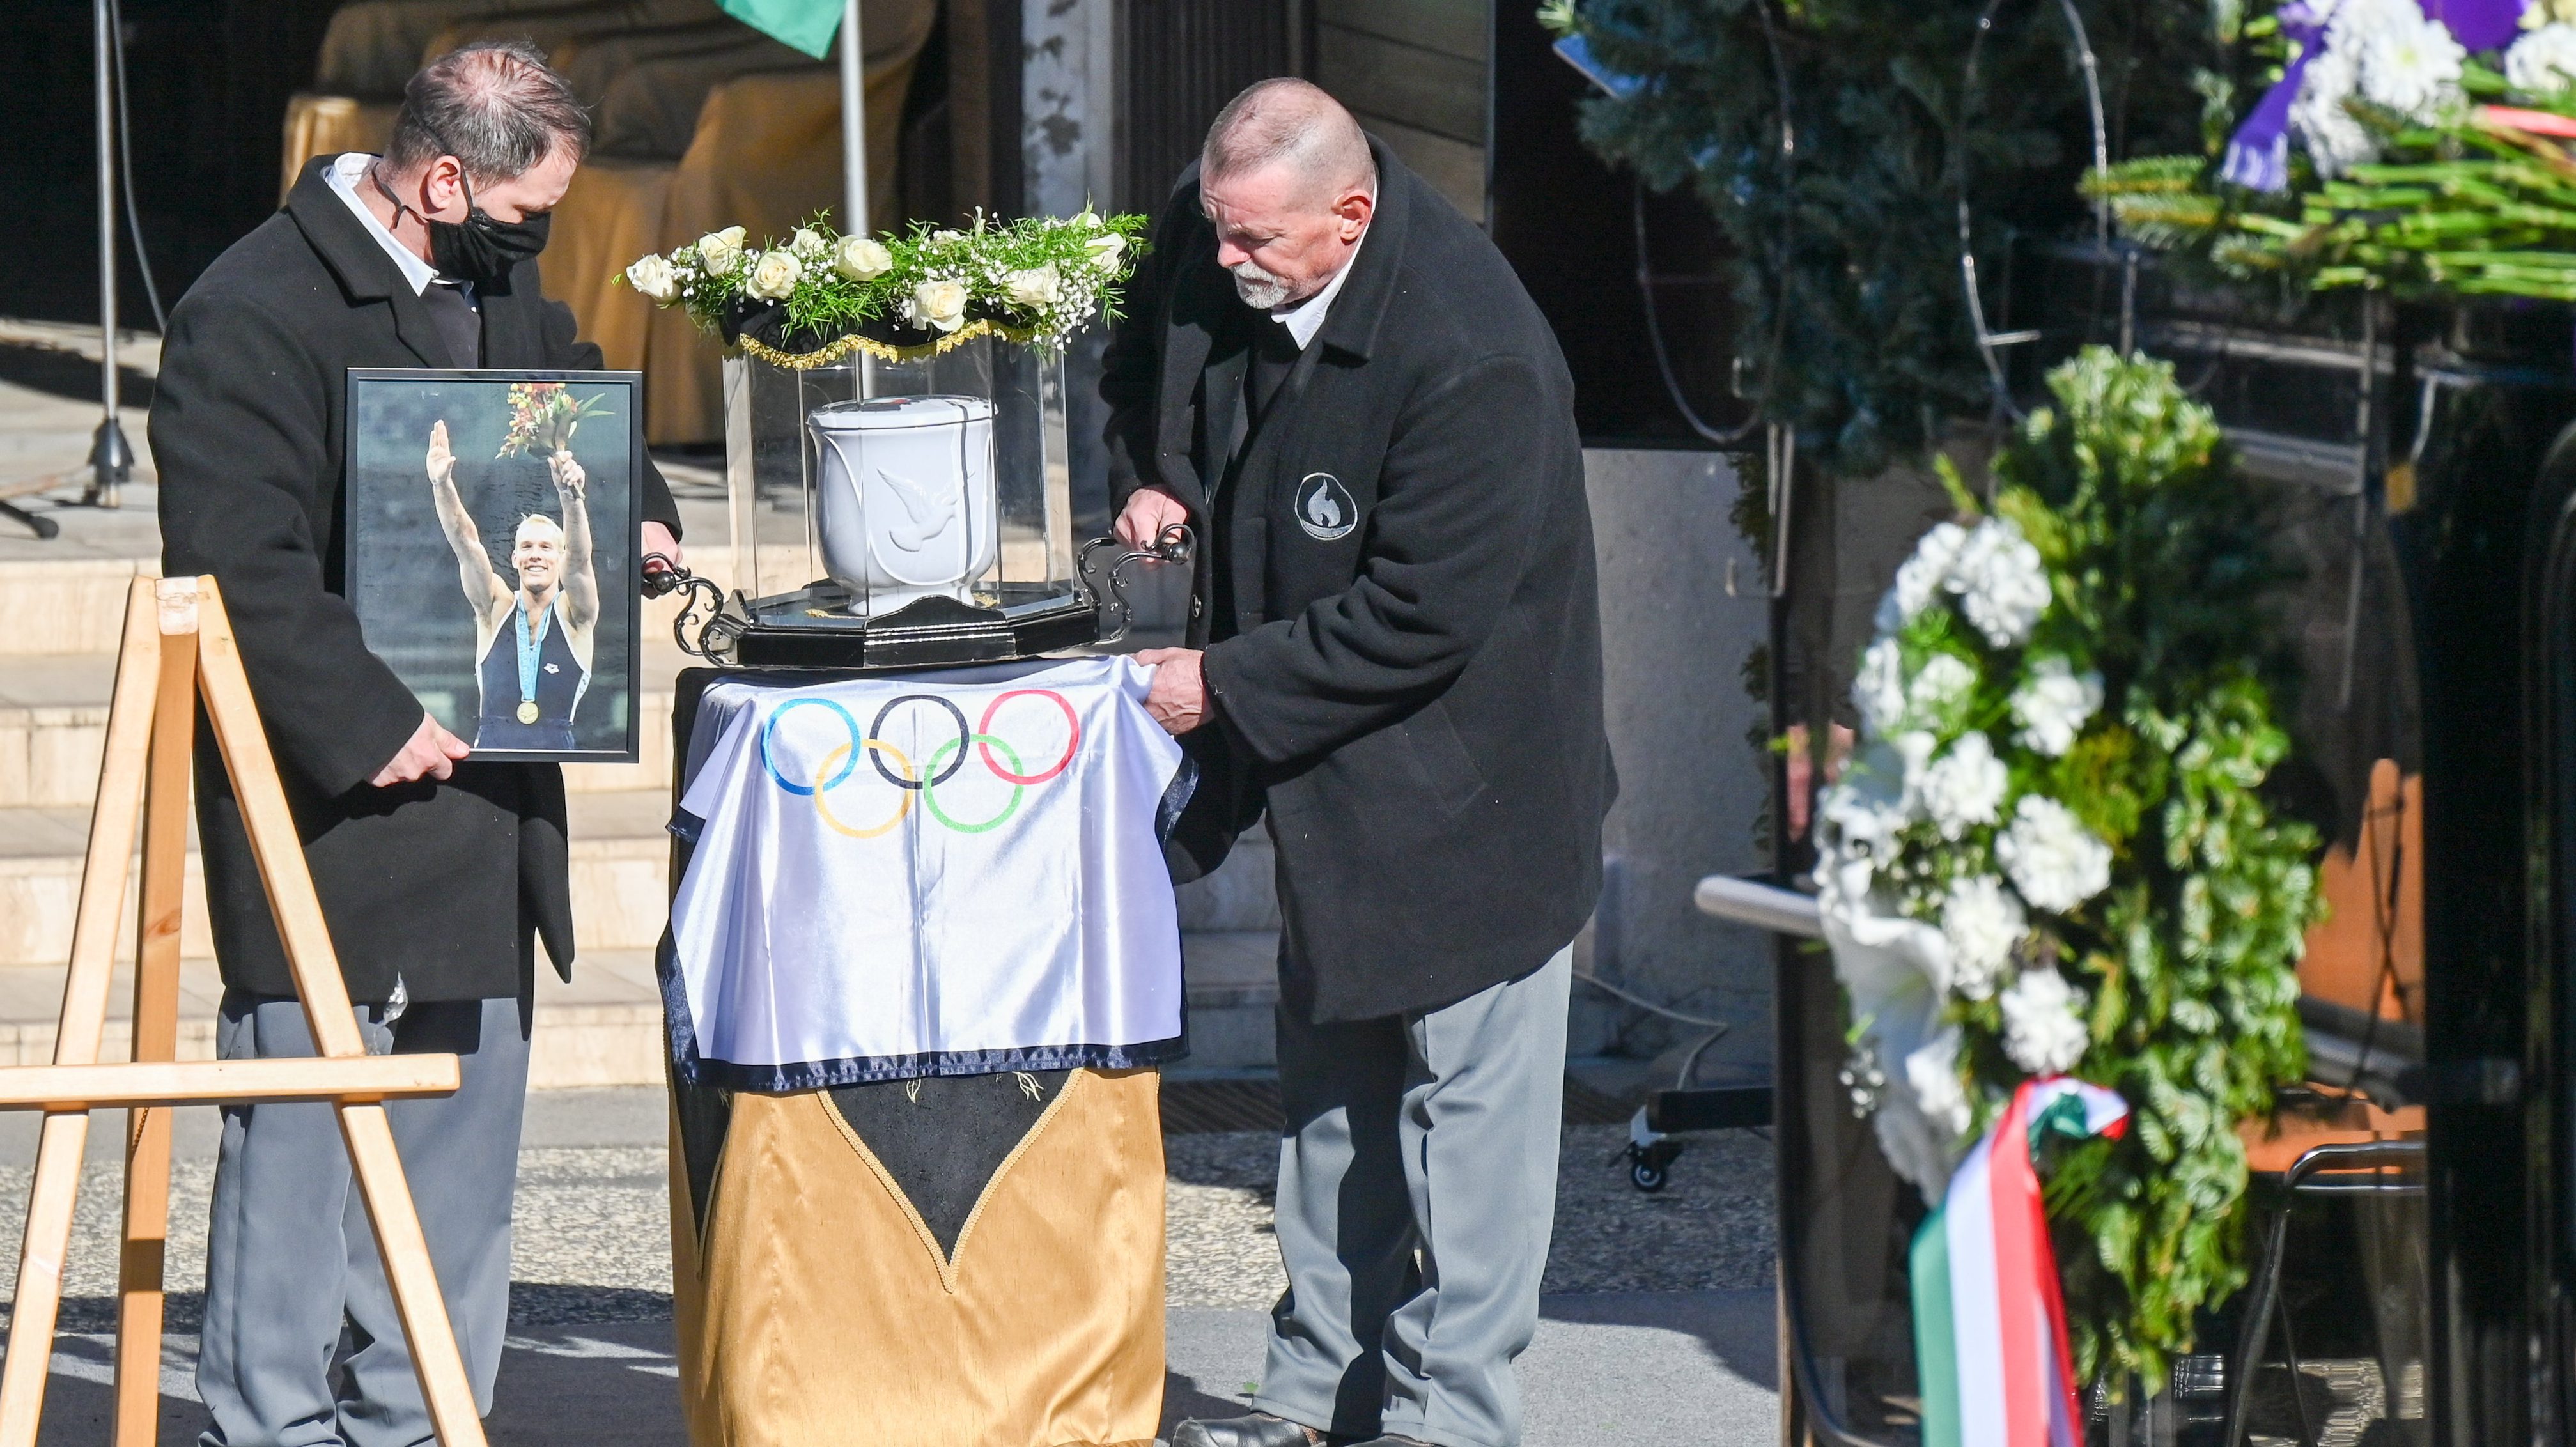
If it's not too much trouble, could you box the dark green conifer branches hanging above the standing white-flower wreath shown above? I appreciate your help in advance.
[1540,0,2208,476]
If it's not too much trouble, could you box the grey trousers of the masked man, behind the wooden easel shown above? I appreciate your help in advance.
[196,991,528,1447]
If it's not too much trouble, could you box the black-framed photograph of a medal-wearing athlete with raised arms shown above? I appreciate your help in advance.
[345,368,644,764]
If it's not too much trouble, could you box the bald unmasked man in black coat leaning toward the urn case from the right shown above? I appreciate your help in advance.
[1100,80,1615,1447]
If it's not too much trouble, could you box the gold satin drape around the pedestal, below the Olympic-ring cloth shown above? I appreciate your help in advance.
[670,1071,1165,1447]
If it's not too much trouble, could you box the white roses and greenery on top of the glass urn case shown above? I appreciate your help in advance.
[623,208,1146,366]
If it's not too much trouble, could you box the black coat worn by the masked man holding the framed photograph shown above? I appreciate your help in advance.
[152,157,678,988]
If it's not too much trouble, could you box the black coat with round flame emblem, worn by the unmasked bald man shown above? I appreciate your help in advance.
[1100,139,1618,1019]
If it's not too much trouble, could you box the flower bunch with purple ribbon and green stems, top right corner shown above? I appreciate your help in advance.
[2084,0,2576,301]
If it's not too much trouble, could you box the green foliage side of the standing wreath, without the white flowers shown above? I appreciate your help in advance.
[1996,350,2324,1380]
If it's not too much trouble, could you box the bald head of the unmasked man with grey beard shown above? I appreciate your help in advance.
[1198,80,1378,311]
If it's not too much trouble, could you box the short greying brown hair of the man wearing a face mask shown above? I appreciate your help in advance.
[384,41,590,185]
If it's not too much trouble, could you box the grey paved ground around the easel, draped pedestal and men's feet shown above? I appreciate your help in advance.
[0,1089,1778,1447]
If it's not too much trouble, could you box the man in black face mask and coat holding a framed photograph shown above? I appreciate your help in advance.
[152,43,678,1447]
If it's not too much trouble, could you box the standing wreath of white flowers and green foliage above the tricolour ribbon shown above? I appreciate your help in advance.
[1816,348,2321,1380]
